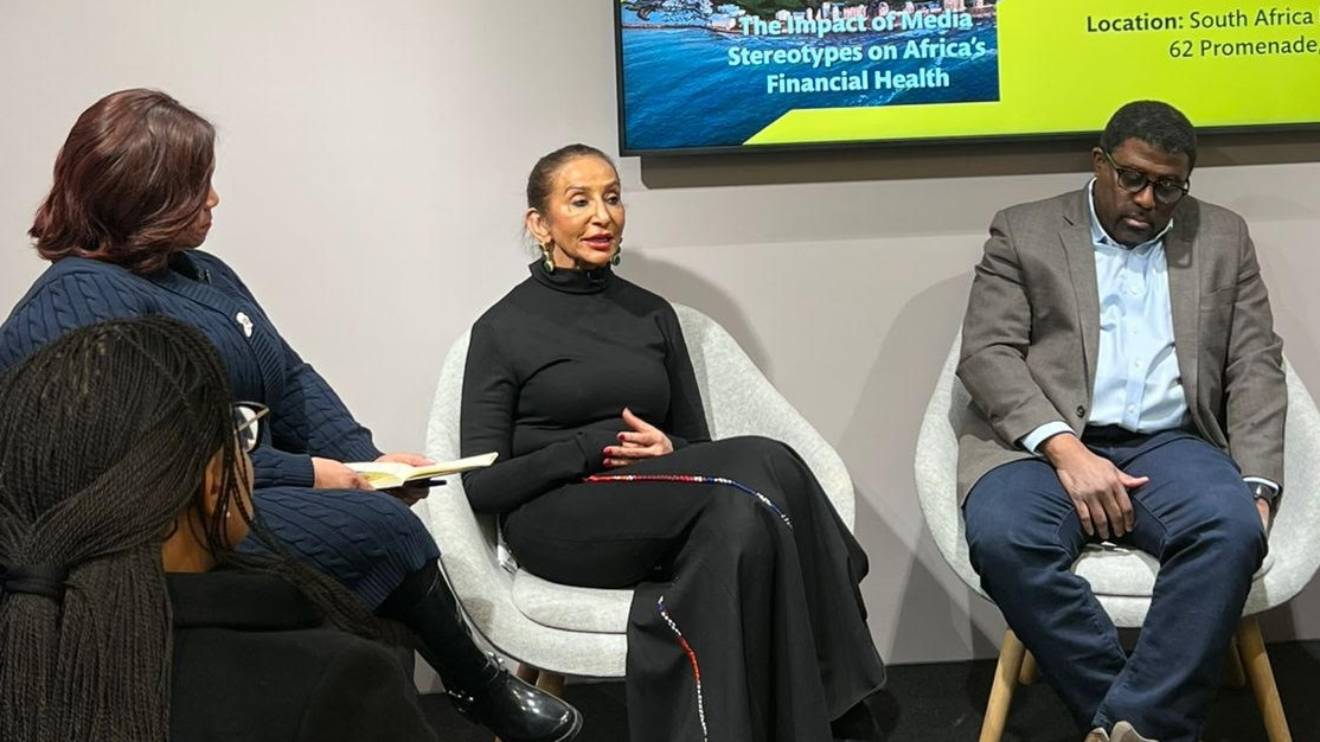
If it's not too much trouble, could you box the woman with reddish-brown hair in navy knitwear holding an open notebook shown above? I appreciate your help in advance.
[0,90,581,741]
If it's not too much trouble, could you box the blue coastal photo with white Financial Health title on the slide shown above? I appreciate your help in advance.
[619,0,999,149]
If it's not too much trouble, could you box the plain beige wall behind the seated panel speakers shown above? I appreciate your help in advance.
[0,0,1320,661]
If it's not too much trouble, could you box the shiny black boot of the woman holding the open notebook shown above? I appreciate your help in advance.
[378,562,582,742]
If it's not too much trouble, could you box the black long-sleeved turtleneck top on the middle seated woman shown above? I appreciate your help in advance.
[461,261,710,514]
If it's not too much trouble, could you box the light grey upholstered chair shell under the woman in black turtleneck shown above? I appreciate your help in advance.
[417,305,854,677]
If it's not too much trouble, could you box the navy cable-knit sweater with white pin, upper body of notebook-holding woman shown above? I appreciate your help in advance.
[0,250,380,487]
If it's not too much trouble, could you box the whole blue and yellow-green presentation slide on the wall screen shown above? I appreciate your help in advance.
[615,0,1320,154]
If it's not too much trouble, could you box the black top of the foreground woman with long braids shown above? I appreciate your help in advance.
[166,570,436,742]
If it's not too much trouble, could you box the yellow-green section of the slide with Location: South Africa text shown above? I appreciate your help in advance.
[747,0,1320,145]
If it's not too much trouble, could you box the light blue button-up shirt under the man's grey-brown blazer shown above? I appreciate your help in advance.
[1022,180,1188,453]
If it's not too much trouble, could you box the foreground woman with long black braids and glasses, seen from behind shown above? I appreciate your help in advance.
[0,317,434,742]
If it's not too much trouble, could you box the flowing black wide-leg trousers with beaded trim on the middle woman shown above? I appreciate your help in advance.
[504,437,884,742]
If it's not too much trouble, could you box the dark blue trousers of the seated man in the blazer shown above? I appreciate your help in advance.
[964,429,1266,742]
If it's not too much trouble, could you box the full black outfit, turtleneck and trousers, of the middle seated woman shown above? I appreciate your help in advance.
[461,263,884,742]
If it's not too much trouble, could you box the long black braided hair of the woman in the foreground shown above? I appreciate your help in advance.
[0,316,380,742]
